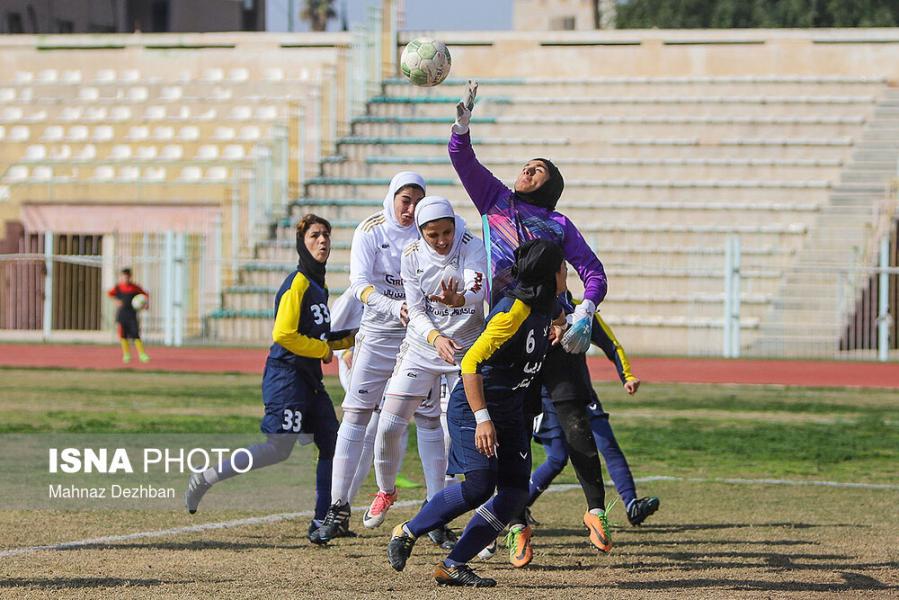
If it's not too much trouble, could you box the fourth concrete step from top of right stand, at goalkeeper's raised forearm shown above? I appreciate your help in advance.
[334,137,853,162]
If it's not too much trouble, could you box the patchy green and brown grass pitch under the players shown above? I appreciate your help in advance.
[0,369,899,599]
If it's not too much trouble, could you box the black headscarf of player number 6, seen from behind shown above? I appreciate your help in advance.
[509,239,564,313]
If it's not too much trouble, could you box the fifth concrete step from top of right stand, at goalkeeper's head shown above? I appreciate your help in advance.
[322,156,843,181]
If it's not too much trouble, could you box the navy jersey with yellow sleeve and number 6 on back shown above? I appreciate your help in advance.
[462,297,561,410]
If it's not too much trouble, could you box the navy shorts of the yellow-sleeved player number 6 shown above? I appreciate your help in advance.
[446,381,531,489]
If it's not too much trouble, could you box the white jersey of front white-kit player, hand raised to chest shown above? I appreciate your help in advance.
[401,217,487,363]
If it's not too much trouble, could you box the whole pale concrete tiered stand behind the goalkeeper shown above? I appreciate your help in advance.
[209,77,887,354]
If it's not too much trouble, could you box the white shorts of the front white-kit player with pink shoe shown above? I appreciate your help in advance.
[385,343,459,416]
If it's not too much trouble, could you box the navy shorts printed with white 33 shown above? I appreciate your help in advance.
[259,359,340,448]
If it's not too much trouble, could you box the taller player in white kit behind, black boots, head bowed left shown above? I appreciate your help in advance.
[309,171,428,544]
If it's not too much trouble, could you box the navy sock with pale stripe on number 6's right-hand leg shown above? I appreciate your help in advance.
[443,488,528,567]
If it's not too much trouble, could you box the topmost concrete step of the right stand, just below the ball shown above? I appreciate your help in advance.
[384,76,887,97]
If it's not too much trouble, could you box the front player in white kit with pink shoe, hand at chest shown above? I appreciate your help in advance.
[363,196,487,528]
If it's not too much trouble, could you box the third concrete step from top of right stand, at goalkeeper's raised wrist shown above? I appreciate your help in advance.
[352,114,864,140]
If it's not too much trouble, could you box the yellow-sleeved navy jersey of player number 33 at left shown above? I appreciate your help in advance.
[268,271,352,386]
